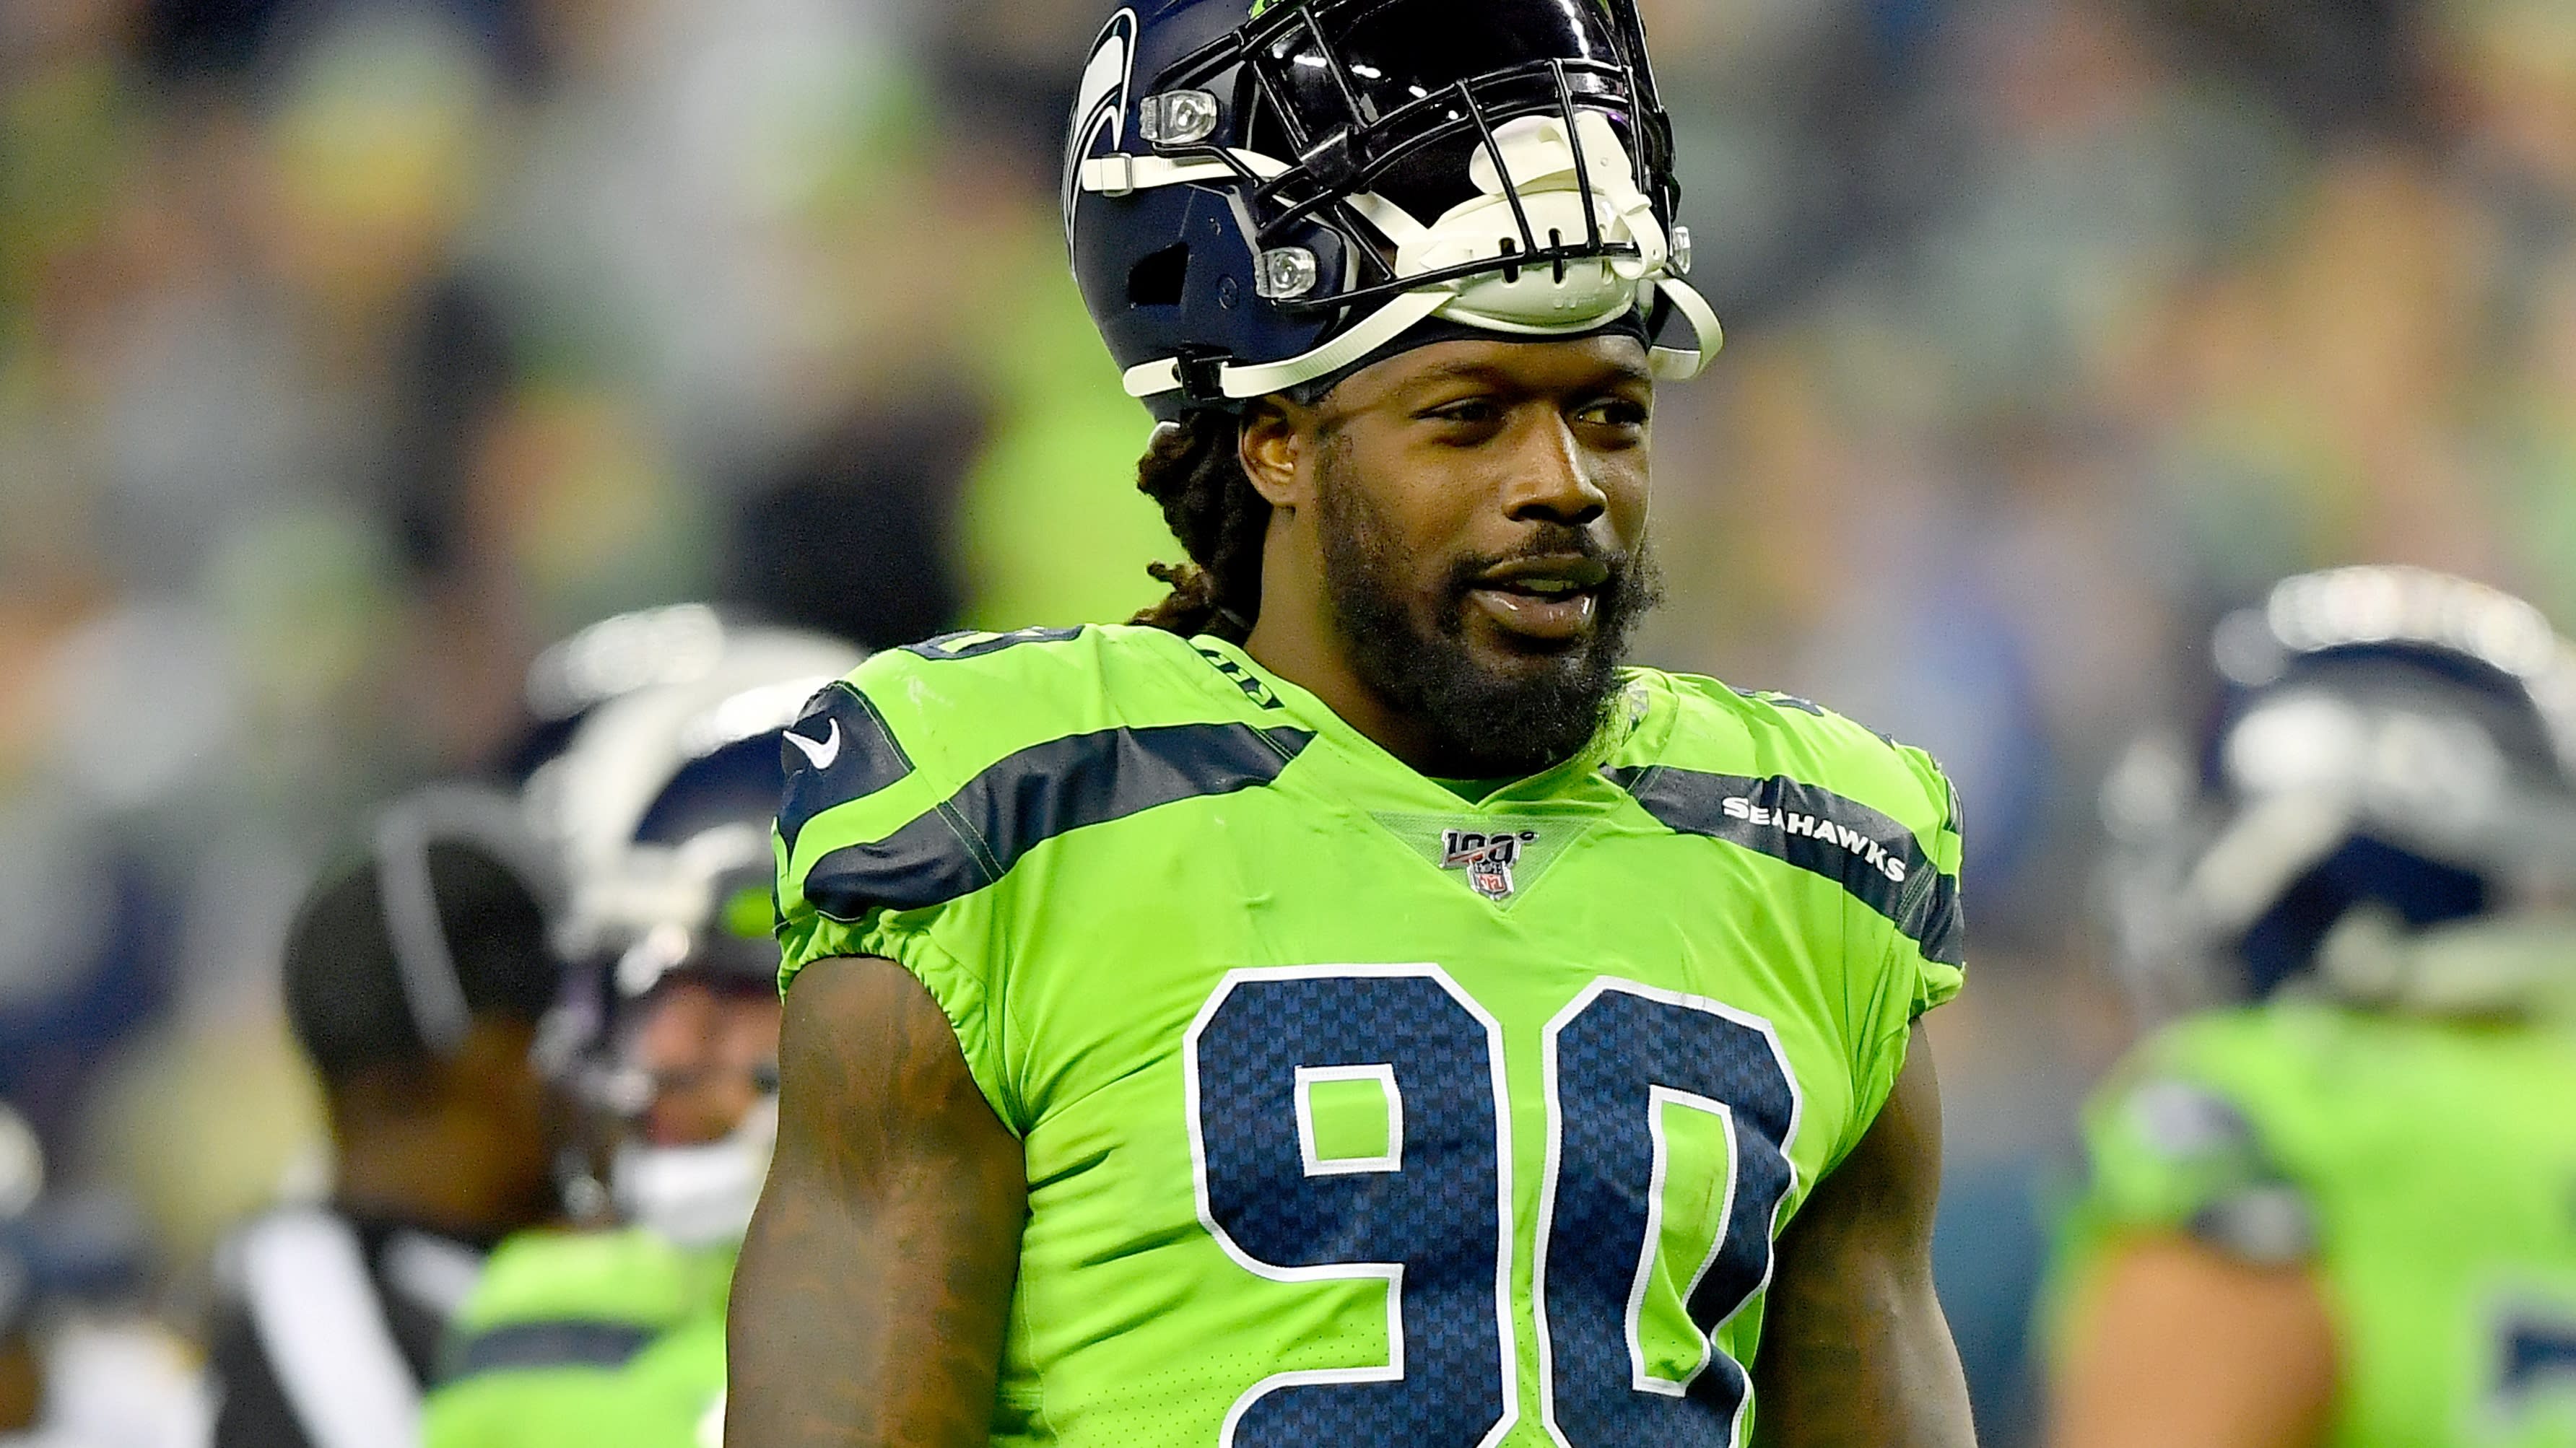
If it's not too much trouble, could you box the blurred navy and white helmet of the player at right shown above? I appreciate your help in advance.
[2102,567,2576,1013]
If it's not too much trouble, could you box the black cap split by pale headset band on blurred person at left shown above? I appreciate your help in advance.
[286,840,559,1082]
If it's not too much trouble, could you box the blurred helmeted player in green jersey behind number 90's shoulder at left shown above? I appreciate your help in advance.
[427,626,863,1448]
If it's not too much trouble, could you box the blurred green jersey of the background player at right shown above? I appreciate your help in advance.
[2053,1000,2576,1448]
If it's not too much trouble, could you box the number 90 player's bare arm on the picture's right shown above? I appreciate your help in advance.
[1754,1026,1967,1448]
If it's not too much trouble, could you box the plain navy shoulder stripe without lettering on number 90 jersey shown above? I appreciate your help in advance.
[804,724,1314,923]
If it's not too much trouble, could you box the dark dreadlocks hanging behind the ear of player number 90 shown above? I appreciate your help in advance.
[1133,410,1270,644]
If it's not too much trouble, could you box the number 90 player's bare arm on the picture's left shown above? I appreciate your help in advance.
[724,959,1028,1448]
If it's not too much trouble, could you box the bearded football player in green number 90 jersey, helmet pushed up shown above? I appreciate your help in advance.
[729,0,1971,1448]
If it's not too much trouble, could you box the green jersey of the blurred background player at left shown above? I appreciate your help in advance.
[422,1229,734,1448]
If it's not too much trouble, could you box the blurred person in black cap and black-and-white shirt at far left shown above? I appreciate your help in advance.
[209,786,562,1448]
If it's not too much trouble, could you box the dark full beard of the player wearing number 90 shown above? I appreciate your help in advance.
[1316,448,1661,778]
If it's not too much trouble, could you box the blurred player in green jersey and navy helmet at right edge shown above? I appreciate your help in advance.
[2053,567,2576,1448]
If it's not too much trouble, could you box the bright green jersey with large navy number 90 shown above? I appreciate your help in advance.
[778,629,1960,1448]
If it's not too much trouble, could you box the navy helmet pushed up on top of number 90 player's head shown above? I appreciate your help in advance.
[1064,0,1720,422]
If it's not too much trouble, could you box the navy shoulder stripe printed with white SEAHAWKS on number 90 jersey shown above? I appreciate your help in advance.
[1602,765,1968,967]
